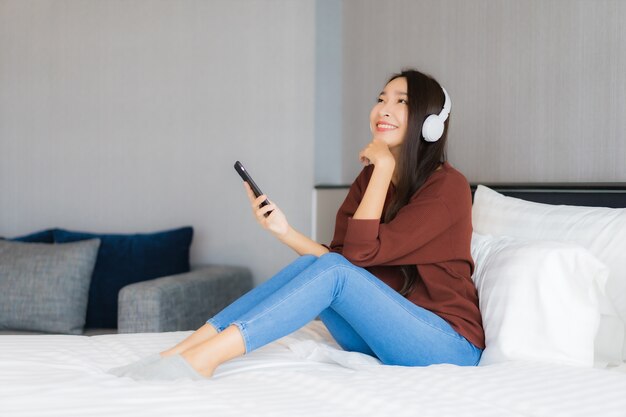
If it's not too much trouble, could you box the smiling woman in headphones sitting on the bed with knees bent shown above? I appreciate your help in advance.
[111,70,484,379]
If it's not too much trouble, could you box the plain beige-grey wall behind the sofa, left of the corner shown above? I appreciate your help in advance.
[0,0,315,281]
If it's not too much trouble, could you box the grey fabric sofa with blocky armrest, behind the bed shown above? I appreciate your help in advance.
[0,265,253,336]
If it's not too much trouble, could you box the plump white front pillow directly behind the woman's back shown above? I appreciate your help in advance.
[472,233,609,367]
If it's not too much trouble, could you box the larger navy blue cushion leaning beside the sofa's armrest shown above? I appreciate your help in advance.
[54,227,193,328]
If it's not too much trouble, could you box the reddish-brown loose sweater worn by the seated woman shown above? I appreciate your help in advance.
[330,162,485,349]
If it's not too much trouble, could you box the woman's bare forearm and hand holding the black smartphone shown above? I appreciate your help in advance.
[244,182,328,256]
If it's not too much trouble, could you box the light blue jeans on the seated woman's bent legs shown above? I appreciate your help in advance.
[207,253,482,366]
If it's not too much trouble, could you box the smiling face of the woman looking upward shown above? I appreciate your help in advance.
[370,77,409,148]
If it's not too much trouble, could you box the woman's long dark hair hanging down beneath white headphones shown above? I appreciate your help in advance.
[383,69,450,296]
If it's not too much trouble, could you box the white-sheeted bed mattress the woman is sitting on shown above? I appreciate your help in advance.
[0,322,626,417]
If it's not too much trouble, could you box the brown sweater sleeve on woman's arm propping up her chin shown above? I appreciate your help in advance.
[342,172,472,267]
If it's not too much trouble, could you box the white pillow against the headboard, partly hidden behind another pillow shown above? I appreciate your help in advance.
[472,185,626,363]
